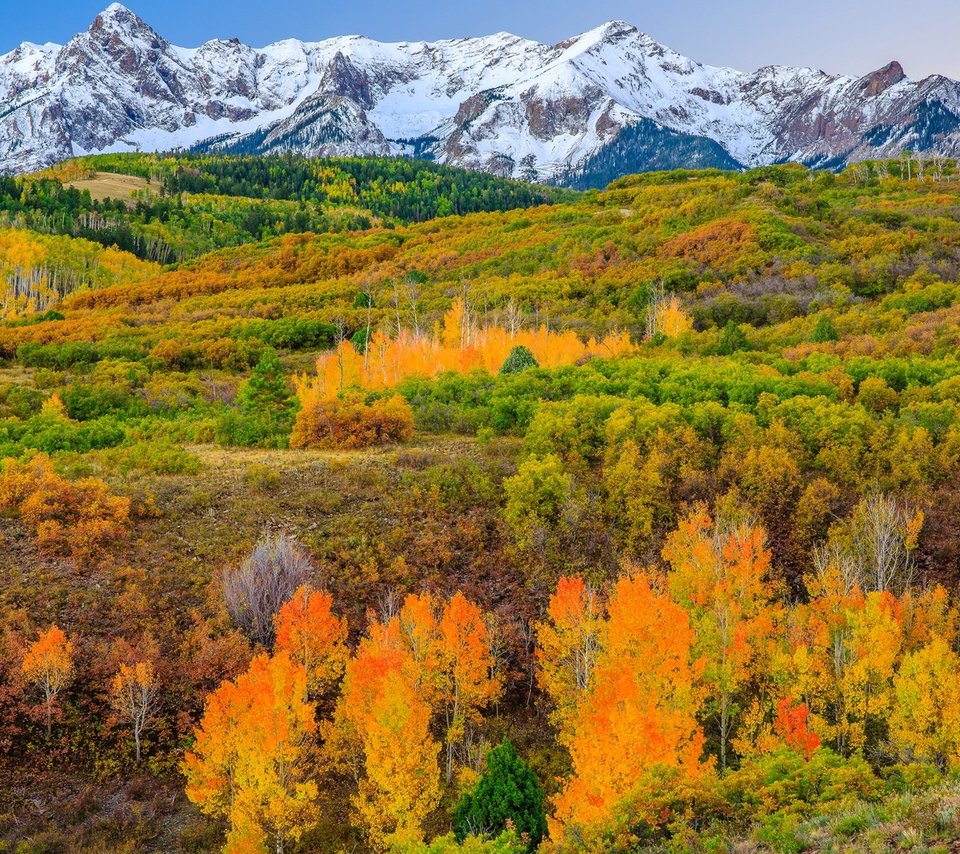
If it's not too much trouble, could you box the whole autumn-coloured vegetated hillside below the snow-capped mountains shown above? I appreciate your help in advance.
[0,155,960,854]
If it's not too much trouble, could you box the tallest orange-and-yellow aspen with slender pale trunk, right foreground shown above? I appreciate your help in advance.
[663,506,773,770]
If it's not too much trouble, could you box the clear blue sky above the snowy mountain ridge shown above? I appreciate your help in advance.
[7,0,960,79]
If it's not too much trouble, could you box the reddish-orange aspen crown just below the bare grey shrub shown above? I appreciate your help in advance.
[274,585,347,699]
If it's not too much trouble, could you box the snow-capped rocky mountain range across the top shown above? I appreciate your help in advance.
[0,4,960,184]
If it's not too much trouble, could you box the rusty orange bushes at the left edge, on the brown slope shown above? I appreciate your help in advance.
[0,454,130,560]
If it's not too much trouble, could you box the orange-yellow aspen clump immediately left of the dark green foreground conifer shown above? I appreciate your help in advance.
[327,593,501,848]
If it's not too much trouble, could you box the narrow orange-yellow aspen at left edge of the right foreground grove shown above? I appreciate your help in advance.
[536,577,605,742]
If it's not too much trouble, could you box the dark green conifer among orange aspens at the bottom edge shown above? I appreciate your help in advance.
[453,741,547,851]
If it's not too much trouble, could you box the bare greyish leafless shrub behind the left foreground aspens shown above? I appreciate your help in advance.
[223,534,313,649]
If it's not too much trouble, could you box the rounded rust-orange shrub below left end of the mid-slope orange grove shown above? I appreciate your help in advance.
[290,394,413,448]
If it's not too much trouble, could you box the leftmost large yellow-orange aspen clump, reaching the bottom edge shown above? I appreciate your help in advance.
[183,652,317,854]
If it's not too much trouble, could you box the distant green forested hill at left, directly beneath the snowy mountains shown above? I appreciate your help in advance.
[0,154,570,264]
